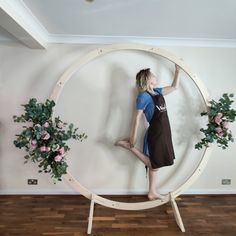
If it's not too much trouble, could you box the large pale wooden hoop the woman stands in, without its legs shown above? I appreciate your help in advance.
[50,44,212,210]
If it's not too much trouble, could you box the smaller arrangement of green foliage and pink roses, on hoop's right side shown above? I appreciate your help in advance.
[195,93,236,149]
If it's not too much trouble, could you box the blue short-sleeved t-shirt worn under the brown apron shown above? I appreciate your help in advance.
[136,88,162,122]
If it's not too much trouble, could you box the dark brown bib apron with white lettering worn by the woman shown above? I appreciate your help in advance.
[147,92,175,169]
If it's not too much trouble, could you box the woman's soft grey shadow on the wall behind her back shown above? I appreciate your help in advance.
[98,65,142,192]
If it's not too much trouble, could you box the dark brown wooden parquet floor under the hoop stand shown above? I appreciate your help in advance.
[0,195,236,236]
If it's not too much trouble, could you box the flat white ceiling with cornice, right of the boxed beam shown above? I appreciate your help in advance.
[0,0,236,48]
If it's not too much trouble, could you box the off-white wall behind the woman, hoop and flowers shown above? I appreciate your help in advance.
[0,43,236,194]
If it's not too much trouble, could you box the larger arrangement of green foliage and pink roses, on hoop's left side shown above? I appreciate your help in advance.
[13,98,87,181]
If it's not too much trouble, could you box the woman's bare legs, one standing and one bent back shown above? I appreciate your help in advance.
[115,140,164,200]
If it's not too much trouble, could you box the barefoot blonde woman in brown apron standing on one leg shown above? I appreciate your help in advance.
[116,65,180,200]
